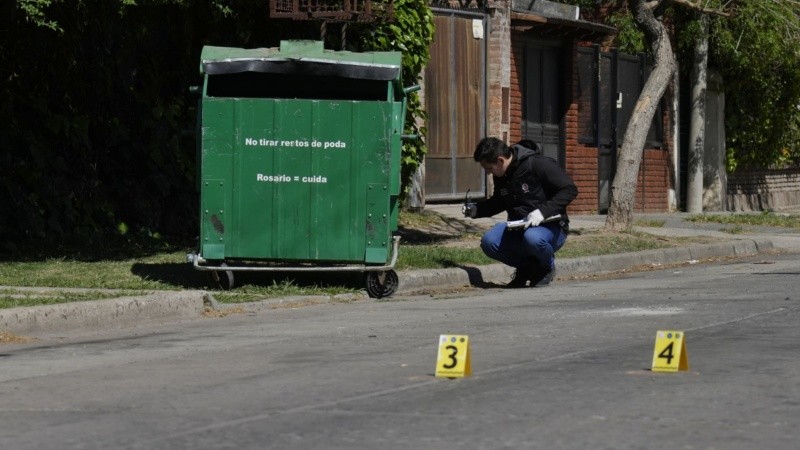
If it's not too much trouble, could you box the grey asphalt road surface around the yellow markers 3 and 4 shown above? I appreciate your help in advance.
[0,255,800,449]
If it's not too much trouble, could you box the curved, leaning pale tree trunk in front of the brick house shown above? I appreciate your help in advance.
[605,0,675,231]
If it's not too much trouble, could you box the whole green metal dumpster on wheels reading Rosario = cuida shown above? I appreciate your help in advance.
[188,41,416,297]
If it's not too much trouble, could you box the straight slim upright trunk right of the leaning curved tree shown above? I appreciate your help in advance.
[686,13,709,213]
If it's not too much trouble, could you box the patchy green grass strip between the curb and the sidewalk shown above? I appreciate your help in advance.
[0,212,776,308]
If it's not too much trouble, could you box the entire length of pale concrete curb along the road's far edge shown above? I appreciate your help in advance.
[0,239,774,334]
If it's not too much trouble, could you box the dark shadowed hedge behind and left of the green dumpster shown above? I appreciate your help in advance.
[0,0,427,254]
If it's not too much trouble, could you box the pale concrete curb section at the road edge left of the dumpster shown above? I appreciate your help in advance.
[0,291,206,334]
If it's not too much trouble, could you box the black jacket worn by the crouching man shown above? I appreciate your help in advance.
[476,145,578,228]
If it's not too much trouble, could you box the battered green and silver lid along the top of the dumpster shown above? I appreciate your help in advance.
[200,41,401,81]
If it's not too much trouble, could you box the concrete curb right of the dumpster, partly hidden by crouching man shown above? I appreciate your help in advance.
[397,238,774,294]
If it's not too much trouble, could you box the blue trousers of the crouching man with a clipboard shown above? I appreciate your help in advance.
[481,222,567,270]
